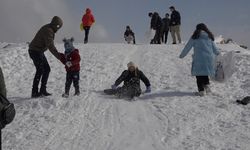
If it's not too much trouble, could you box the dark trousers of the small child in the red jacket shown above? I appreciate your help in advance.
[65,71,80,94]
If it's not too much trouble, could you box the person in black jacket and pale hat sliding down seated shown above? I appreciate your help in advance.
[111,62,151,98]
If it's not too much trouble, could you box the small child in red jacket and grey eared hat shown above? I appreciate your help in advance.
[61,37,81,98]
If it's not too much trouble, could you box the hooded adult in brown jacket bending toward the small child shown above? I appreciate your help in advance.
[28,16,63,98]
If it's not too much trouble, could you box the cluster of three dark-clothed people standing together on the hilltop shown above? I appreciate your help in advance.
[148,6,181,44]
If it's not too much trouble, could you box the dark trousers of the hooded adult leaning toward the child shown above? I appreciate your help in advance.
[29,50,50,93]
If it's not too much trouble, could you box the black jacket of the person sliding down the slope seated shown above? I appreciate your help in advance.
[115,69,150,87]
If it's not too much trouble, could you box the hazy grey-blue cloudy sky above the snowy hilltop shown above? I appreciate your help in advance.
[0,0,250,47]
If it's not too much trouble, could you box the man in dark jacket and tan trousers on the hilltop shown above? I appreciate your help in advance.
[169,6,181,44]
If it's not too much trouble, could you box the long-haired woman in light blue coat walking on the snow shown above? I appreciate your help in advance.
[179,23,219,96]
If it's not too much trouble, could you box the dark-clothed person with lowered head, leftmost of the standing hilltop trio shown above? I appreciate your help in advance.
[148,12,162,44]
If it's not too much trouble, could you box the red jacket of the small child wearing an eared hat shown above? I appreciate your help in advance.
[61,49,81,72]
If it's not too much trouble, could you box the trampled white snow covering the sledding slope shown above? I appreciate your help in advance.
[0,43,250,150]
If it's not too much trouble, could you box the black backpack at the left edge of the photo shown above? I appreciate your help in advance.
[0,94,16,129]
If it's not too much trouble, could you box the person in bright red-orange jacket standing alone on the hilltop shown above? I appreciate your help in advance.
[82,8,95,44]
